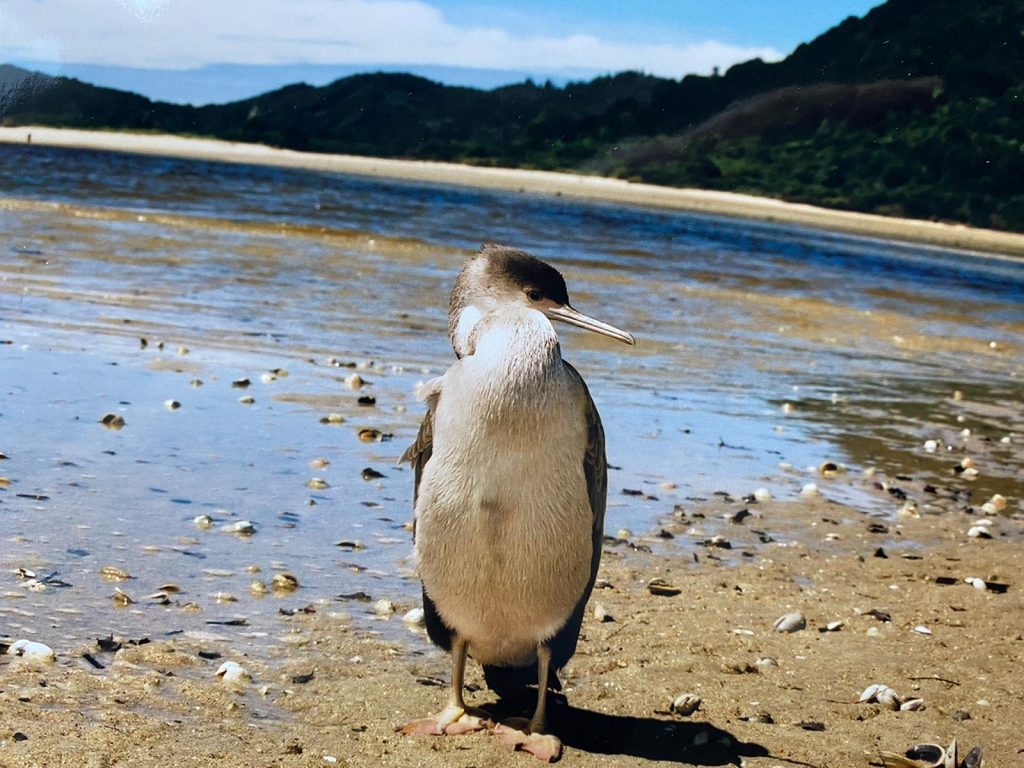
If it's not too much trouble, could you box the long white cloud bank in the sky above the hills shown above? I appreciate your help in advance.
[0,0,781,77]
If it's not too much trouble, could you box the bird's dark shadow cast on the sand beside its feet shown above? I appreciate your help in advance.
[486,696,770,765]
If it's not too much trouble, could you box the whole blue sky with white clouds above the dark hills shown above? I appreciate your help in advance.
[0,0,881,103]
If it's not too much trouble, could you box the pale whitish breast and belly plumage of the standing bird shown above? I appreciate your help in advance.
[416,309,592,664]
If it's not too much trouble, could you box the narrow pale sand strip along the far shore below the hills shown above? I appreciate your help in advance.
[0,126,1024,257]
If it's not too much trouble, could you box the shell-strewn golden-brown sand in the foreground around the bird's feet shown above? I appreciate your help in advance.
[0,500,1024,768]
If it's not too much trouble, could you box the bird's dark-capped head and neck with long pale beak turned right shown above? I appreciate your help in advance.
[449,243,635,357]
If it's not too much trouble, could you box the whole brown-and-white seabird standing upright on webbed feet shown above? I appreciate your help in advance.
[398,244,635,761]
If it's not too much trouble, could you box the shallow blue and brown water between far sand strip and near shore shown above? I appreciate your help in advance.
[0,146,1024,652]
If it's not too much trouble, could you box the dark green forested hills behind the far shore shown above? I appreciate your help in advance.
[0,0,1024,231]
